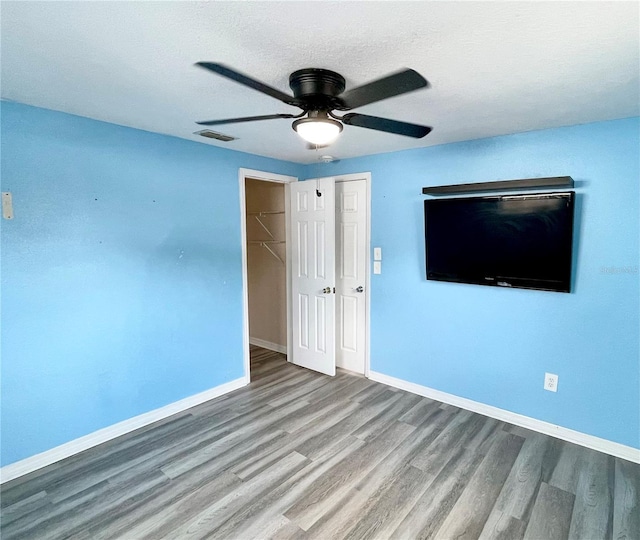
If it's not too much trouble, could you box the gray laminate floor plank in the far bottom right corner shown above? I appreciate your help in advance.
[613,458,640,540]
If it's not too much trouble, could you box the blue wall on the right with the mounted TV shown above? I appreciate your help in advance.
[305,118,640,448]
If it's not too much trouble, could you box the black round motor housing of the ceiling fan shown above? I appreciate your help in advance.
[289,68,345,110]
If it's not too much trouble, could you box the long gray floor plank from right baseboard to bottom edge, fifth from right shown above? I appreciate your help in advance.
[436,434,524,540]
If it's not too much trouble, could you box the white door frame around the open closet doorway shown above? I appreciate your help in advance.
[238,168,298,384]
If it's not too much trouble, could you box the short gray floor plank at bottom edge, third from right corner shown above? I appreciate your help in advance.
[524,482,576,540]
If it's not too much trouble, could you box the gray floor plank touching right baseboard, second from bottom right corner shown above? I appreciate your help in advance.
[569,450,614,540]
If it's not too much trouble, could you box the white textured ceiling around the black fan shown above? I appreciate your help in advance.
[1,1,640,163]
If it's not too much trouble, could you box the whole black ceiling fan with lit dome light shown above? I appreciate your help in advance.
[196,62,432,146]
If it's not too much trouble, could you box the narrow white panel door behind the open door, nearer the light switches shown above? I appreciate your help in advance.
[336,180,368,374]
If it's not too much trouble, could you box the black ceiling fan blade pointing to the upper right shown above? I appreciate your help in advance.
[338,69,429,111]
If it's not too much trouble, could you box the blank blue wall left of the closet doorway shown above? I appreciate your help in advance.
[1,102,301,465]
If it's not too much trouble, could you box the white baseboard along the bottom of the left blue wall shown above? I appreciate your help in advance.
[0,377,247,484]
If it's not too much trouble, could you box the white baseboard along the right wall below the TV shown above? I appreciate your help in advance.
[369,371,640,463]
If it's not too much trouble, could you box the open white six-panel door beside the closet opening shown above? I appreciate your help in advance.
[289,178,336,375]
